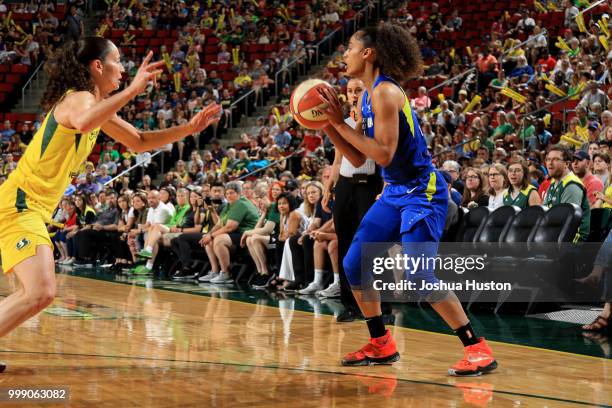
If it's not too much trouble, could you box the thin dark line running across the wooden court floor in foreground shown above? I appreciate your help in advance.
[0,350,612,408]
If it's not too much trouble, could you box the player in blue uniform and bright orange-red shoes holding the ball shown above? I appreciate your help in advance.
[320,23,497,376]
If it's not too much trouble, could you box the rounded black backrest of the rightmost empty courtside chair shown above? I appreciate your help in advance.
[528,203,582,243]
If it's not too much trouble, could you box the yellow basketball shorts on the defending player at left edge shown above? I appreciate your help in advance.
[0,183,53,273]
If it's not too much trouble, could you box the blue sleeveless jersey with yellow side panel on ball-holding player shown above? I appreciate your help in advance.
[361,74,434,185]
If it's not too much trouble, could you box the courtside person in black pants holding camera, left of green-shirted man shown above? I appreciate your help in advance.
[170,182,227,279]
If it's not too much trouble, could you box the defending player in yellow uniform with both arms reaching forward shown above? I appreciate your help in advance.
[0,37,221,372]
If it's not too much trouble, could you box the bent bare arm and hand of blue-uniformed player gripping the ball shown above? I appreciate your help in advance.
[320,84,404,167]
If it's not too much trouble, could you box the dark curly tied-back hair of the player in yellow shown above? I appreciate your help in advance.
[41,37,112,110]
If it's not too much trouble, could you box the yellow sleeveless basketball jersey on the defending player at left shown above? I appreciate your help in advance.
[0,108,100,221]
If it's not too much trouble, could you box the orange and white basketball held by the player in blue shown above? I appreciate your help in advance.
[289,79,334,129]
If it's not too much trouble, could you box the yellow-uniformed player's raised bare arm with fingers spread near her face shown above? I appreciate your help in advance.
[60,52,164,133]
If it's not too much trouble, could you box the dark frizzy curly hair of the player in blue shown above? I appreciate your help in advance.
[356,23,423,81]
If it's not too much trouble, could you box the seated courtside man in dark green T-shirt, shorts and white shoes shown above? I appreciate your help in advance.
[200,181,259,283]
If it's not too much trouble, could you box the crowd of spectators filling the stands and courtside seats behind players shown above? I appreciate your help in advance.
[0,0,612,312]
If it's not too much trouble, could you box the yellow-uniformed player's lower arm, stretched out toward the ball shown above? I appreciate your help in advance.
[102,103,221,153]
